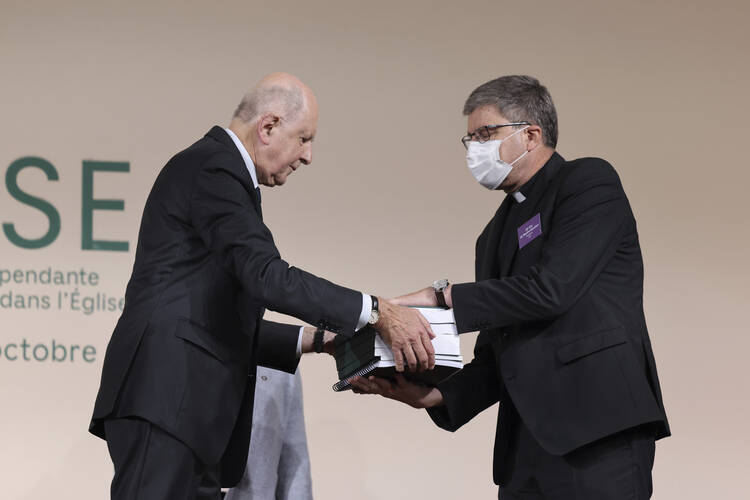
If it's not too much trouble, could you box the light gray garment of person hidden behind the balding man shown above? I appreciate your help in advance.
[225,366,312,500]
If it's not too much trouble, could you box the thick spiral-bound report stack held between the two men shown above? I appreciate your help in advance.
[333,307,463,392]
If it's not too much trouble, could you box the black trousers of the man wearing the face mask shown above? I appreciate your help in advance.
[498,423,655,500]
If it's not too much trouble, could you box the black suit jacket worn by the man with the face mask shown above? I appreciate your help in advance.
[429,153,669,484]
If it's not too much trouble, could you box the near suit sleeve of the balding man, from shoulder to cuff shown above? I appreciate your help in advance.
[190,155,362,334]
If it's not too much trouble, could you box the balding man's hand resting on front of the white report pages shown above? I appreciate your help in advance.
[374,300,435,372]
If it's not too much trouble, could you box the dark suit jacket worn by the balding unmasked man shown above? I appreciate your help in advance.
[90,127,362,484]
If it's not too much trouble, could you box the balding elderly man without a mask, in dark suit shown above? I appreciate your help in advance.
[90,73,434,500]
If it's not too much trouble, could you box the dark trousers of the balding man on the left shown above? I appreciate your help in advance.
[104,418,221,500]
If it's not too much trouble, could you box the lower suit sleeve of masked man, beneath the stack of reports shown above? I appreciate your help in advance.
[427,332,500,432]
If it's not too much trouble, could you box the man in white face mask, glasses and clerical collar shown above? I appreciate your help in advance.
[354,76,670,500]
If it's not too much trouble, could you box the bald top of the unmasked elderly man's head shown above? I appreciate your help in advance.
[232,73,317,123]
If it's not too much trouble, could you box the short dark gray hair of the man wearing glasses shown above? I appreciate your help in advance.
[464,75,557,148]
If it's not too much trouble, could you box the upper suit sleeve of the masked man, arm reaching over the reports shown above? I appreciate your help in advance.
[451,159,630,332]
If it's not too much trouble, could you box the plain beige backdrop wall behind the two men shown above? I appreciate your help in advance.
[0,0,750,500]
